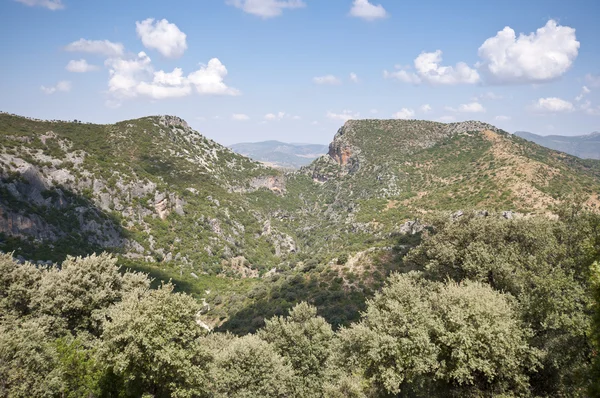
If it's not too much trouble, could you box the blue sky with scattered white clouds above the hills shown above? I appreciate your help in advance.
[0,0,600,145]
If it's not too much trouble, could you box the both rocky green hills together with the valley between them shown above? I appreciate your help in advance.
[0,114,600,333]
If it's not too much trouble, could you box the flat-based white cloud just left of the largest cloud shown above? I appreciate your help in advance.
[383,50,480,85]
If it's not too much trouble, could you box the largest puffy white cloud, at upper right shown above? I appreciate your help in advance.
[478,20,579,84]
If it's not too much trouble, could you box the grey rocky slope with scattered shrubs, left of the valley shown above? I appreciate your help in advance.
[0,114,294,272]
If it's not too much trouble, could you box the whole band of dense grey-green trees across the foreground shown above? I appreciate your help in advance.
[0,208,600,397]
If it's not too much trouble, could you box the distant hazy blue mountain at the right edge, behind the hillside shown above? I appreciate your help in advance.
[515,131,600,159]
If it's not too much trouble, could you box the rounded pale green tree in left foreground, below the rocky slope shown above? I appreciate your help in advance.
[98,284,210,398]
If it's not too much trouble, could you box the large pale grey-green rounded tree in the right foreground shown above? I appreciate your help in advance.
[340,273,535,396]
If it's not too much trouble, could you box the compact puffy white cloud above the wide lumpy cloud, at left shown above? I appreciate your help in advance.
[135,18,187,58]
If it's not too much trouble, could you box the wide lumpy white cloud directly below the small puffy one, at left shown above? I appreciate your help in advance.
[105,52,240,105]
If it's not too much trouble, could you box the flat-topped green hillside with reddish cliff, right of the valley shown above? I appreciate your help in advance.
[280,120,600,258]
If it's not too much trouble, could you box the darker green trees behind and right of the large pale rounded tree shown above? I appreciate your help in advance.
[405,213,600,395]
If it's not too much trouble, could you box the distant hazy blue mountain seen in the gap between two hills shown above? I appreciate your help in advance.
[229,141,329,169]
